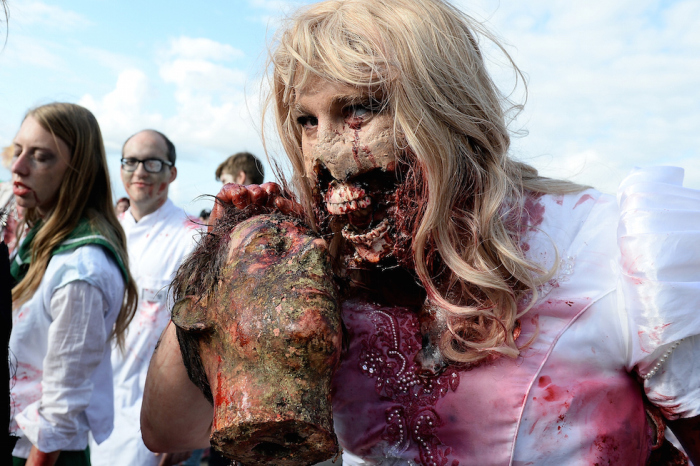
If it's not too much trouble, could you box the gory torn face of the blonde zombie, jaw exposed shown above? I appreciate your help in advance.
[293,78,397,263]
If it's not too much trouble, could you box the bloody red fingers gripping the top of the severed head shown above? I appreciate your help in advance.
[208,182,304,231]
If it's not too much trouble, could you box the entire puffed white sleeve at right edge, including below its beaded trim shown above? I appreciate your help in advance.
[618,167,700,418]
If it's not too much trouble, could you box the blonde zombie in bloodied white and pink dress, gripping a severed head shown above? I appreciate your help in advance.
[142,0,700,465]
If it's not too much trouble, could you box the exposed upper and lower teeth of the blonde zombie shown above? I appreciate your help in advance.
[324,182,393,263]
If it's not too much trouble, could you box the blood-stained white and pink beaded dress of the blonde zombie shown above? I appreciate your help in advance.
[333,167,700,466]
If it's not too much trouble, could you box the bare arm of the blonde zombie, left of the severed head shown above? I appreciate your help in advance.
[141,322,213,452]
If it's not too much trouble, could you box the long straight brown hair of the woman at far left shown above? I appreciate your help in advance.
[12,103,138,346]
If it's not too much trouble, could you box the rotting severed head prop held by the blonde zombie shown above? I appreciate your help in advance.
[172,215,341,466]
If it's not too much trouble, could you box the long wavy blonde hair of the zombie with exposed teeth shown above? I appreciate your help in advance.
[268,0,583,363]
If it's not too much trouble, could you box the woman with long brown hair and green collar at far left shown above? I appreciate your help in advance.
[10,103,136,465]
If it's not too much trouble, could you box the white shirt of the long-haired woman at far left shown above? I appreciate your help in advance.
[10,245,124,458]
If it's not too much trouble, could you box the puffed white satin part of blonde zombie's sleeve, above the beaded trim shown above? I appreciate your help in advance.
[617,167,700,363]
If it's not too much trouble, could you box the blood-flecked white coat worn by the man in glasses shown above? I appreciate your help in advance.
[90,199,199,466]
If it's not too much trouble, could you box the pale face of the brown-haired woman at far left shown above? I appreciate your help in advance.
[12,116,71,216]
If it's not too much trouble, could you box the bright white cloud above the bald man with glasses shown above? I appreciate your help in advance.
[80,38,260,152]
